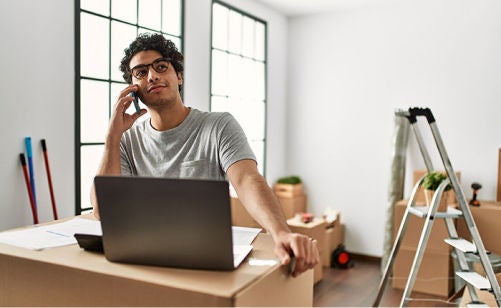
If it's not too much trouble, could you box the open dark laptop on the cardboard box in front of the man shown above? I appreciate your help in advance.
[94,176,246,270]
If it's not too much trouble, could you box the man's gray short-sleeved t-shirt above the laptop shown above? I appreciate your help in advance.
[120,108,256,180]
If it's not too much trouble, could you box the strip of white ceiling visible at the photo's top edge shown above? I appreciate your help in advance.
[255,0,398,16]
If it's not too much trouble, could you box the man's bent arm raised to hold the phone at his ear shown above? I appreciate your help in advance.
[90,85,146,219]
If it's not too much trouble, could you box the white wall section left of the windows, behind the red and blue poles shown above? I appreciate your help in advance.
[0,0,75,230]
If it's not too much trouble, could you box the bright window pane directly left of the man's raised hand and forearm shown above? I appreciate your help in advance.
[80,80,109,143]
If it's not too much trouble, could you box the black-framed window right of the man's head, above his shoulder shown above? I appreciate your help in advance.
[210,1,266,175]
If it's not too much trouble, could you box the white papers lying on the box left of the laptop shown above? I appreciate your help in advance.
[0,217,102,250]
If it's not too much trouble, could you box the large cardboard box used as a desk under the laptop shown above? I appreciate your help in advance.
[0,215,313,307]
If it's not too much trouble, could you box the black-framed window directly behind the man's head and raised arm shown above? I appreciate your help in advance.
[75,0,184,214]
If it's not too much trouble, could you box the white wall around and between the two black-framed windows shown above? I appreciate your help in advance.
[0,0,287,230]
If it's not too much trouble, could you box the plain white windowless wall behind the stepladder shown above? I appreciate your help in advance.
[287,0,501,256]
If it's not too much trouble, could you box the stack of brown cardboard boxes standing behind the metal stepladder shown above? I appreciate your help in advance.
[392,170,460,297]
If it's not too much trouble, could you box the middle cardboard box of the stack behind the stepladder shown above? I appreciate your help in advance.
[393,200,452,253]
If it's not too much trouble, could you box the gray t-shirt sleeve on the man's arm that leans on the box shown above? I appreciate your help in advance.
[219,113,256,172]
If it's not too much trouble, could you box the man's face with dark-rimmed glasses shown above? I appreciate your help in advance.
[129,50,183,106]
